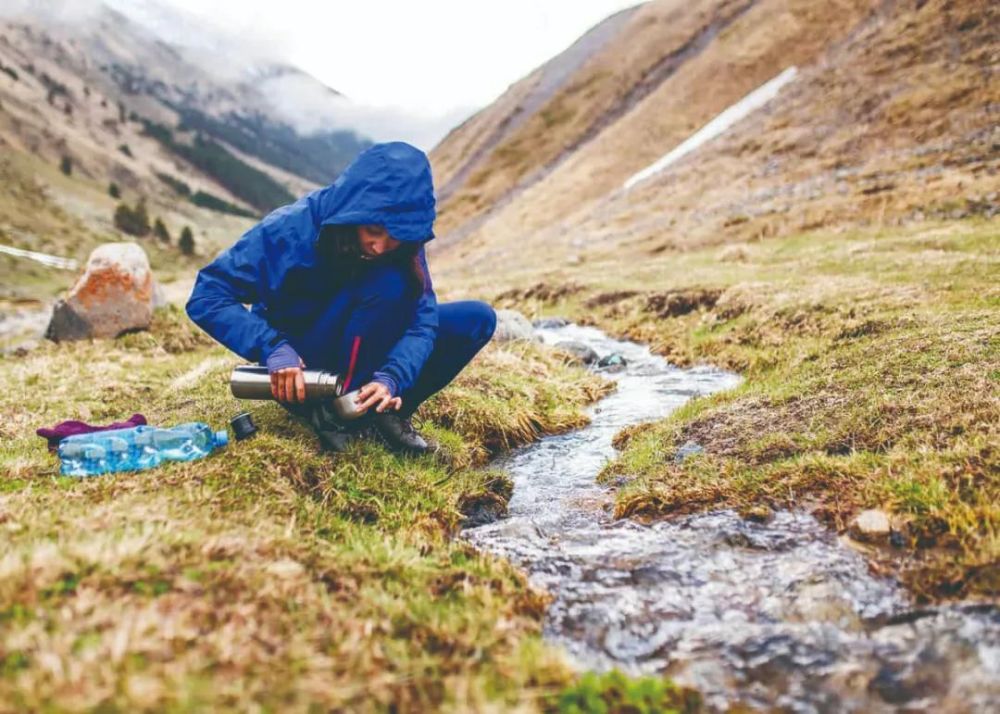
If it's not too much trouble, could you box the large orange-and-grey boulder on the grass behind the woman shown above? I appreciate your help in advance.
[45,243,155,342]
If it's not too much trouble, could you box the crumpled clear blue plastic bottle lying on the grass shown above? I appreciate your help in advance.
[59,422,229,476]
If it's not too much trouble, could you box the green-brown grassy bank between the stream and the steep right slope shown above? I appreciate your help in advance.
[488,221,1000,598]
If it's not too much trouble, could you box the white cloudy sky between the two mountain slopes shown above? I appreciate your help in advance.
[148,0,638,117]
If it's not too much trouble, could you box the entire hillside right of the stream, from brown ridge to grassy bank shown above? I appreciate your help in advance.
[433,0,1000,600]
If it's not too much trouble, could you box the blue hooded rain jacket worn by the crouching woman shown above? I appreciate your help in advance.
[187,142,438,394]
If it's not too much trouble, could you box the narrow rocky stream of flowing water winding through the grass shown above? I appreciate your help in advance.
[465,325,1000,712]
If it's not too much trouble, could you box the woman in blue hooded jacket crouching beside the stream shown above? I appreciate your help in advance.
[187,142,496,453]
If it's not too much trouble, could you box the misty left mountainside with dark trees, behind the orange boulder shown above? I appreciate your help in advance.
[0,2,378,334]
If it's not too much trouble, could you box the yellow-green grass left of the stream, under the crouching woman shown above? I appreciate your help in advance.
[0,308,712,711]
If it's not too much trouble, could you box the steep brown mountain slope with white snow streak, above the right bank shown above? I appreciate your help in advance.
[433,0,1000,271]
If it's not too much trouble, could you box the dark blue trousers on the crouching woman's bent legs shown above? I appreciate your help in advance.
[290,265,497,416]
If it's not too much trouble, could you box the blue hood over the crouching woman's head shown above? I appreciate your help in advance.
[314,141,437,243]
